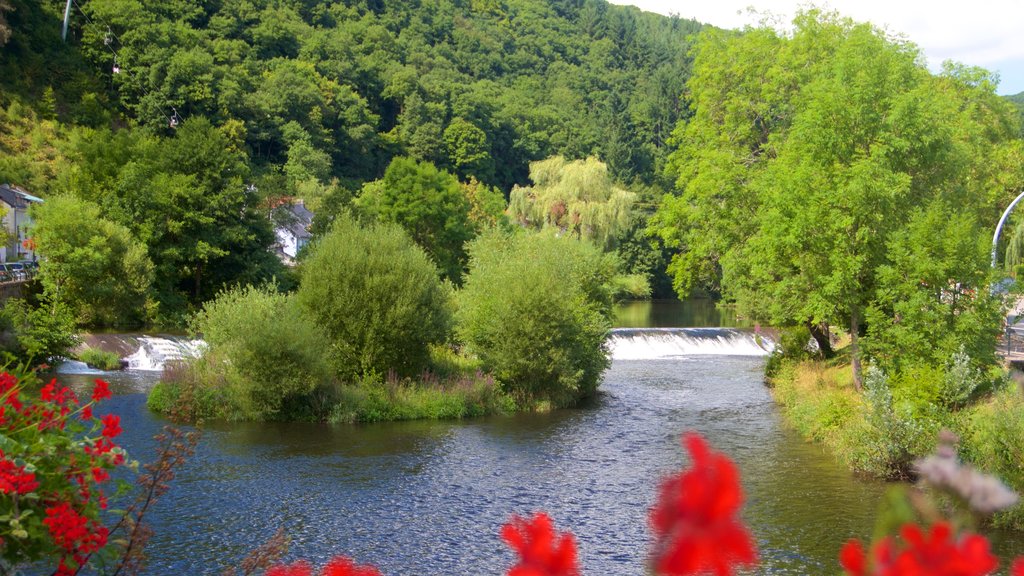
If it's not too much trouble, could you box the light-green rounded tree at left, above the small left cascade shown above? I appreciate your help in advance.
[32,196,153,326]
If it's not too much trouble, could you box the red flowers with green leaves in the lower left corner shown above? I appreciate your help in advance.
[0,372,124,574]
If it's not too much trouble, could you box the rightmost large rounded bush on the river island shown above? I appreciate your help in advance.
[458,226,616,406]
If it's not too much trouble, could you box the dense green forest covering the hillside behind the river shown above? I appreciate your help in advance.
[0,0,701,322]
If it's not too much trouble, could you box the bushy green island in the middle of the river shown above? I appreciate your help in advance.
[148,215,634,421]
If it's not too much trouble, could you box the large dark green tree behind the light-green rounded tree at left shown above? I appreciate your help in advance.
[68,118,283,321]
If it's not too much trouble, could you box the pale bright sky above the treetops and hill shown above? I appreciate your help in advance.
[610,0,1024,94]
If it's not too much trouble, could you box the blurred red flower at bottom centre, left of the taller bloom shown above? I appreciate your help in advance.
[502,512,580,576]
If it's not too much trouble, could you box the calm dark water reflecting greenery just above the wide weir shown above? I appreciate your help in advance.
[614,298,754,328]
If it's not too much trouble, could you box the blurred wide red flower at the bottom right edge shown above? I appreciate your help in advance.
[840,522,999,576]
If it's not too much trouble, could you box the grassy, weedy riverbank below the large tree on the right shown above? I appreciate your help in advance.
[768,360,1024,530]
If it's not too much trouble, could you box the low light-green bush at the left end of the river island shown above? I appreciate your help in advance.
[193,287,332,420]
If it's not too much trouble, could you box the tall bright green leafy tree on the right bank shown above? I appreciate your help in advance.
[654,10,1019,382]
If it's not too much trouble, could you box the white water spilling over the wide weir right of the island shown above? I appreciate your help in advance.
[608,328,775,360]
